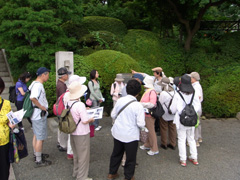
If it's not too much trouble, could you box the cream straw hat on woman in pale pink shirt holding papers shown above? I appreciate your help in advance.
[68,81,87,100]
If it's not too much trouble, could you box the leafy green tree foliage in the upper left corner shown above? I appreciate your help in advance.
[0,0,81,76]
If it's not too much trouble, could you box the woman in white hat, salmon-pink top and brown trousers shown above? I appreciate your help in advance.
[140,76,159,156]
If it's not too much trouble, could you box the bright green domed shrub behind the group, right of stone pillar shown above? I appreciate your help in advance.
[74,50,140,112]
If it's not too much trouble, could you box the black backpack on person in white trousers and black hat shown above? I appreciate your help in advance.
[178,91,198,127]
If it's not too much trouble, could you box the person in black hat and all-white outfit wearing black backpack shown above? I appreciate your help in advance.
[170,74,201,167]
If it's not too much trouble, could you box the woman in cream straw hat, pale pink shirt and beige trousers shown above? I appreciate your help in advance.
[66,81,94,180]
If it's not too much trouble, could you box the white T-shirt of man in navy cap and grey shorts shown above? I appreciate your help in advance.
[29,81,48,120]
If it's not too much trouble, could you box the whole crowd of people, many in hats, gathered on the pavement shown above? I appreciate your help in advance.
[0,67,203,180]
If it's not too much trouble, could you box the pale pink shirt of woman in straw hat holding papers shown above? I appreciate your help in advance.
[68,101,90,135]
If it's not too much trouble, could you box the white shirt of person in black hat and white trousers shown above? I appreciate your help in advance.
[170,92,201,130]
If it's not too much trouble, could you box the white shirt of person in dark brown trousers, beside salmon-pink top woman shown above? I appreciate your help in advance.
[159,91,174,121]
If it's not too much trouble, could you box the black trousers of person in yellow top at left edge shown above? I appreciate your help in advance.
[0,143,10,180]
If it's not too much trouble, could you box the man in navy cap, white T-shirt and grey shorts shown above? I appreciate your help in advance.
[29,67,52,168]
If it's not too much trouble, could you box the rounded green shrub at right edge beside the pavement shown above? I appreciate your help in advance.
[203,67,240,117]
